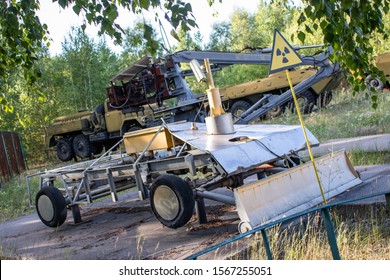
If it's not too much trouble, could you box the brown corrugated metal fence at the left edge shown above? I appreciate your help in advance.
[0,131,26,184]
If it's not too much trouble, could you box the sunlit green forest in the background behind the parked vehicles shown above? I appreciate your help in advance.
[0,1,390,165]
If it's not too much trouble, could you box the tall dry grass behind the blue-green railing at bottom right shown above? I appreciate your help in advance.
[241,205,390,260]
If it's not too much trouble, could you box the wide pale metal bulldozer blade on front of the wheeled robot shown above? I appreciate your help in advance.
[234,151,362,232]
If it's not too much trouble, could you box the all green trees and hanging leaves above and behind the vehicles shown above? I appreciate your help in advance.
[0,0,390,164]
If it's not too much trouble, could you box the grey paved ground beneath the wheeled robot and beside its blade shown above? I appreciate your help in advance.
[0,165,390,260]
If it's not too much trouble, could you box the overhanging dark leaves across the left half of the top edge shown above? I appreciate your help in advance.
[0,0,195,112]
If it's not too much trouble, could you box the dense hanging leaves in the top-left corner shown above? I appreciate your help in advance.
[0,1,49,112]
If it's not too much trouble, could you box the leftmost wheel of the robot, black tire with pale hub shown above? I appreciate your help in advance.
[35,186,67,227]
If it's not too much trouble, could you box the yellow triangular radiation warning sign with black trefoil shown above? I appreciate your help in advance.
[269,29,302,74]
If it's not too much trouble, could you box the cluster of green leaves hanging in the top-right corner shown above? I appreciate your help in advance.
[298,0,390,108]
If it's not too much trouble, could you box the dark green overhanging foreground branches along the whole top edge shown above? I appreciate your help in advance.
[0,0,390,92]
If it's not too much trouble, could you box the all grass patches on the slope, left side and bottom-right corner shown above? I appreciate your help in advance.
[0,86,390,259]
